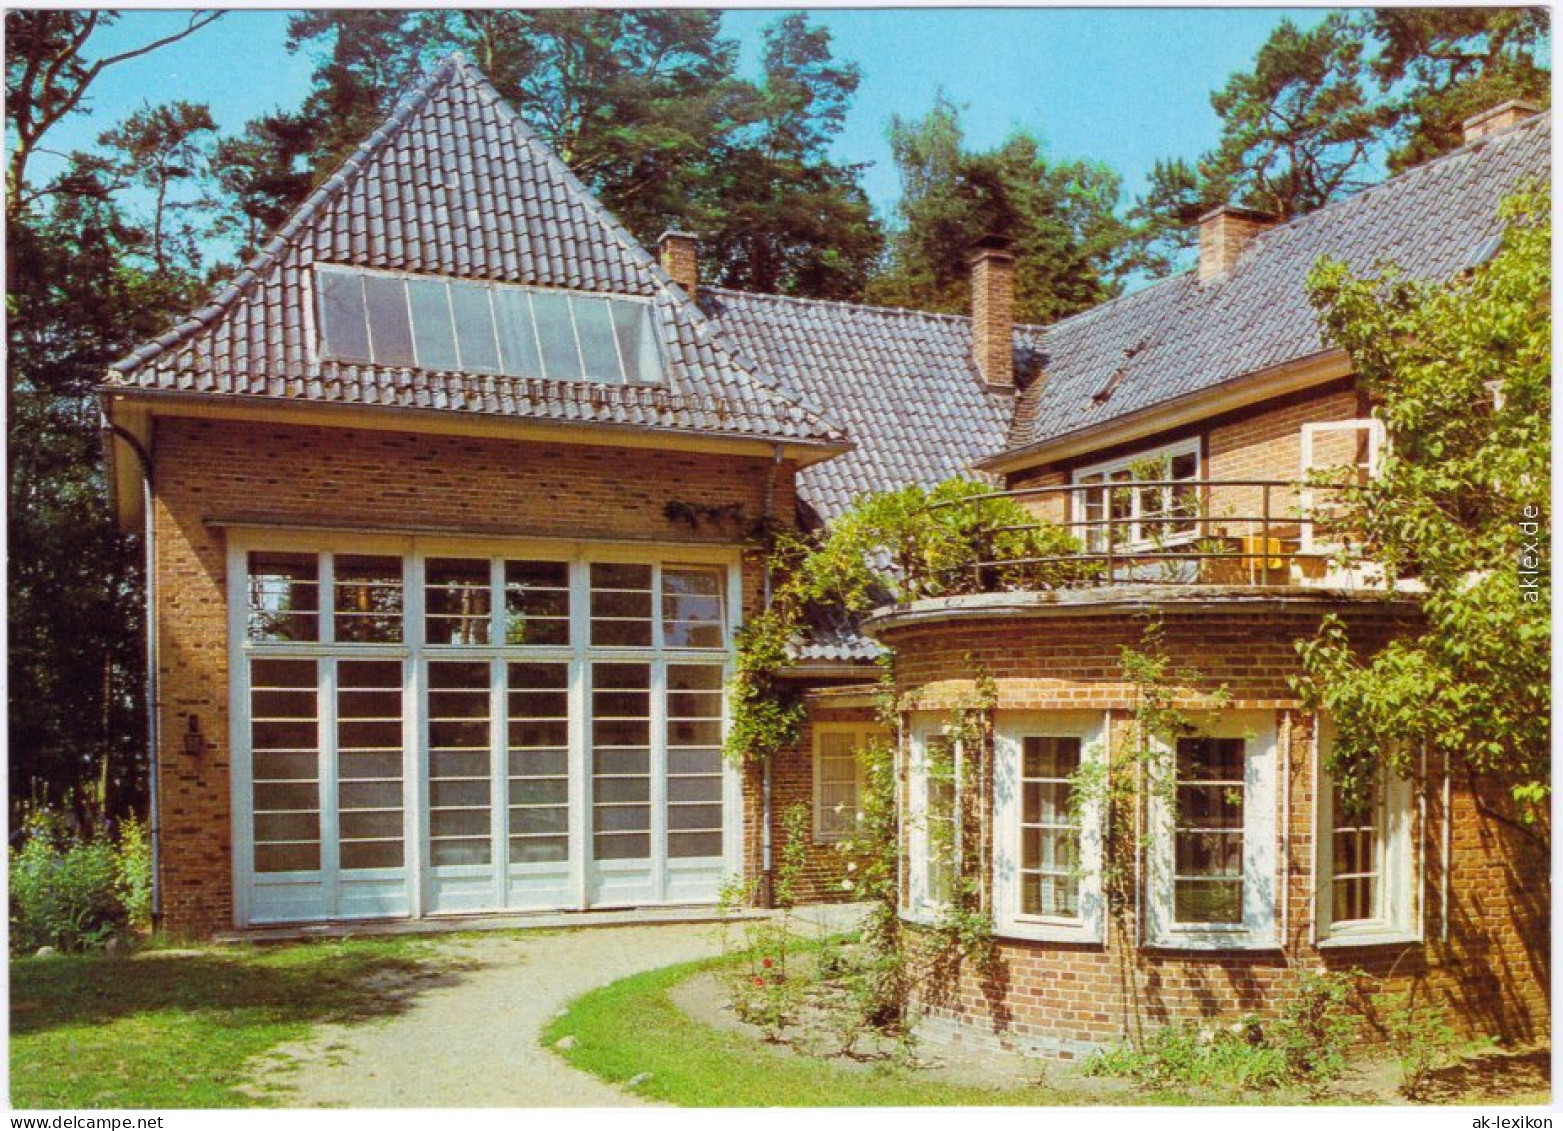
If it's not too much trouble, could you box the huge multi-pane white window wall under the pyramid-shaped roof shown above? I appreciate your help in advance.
[228,528,741,925]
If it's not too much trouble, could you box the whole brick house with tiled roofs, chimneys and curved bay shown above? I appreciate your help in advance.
[103,58,1549,1053]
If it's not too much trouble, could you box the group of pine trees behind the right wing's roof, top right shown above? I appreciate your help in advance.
[1124,8,1552,278]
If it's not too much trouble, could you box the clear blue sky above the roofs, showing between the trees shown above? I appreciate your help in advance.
[36,8,1325,226]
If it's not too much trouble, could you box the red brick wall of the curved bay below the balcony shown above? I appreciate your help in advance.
[883,606,1550,1056]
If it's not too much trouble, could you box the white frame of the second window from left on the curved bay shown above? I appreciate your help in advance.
[993,711,1107,944]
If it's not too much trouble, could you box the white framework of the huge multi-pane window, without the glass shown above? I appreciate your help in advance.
[225,525,742,926]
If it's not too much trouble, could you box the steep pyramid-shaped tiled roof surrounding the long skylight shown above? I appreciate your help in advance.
[109,55,842,445]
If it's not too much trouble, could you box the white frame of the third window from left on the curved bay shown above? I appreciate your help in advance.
[1144,711,1280,950]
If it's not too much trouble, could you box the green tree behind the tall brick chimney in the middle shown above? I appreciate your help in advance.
[869,94,1124,323]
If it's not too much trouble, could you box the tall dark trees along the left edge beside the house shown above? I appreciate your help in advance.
[6,11,226,820]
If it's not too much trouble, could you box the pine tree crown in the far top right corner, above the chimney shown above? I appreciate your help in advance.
[1364,8,1552,172]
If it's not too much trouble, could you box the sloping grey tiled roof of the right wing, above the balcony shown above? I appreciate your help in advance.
[1007,114,1552,450]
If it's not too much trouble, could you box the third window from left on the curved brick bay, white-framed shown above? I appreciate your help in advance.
[1146,711,1280,950]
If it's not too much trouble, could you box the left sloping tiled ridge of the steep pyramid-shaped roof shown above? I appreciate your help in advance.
[109,52,467,373]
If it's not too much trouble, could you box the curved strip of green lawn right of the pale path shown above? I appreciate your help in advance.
[542,958,1206,1108]
